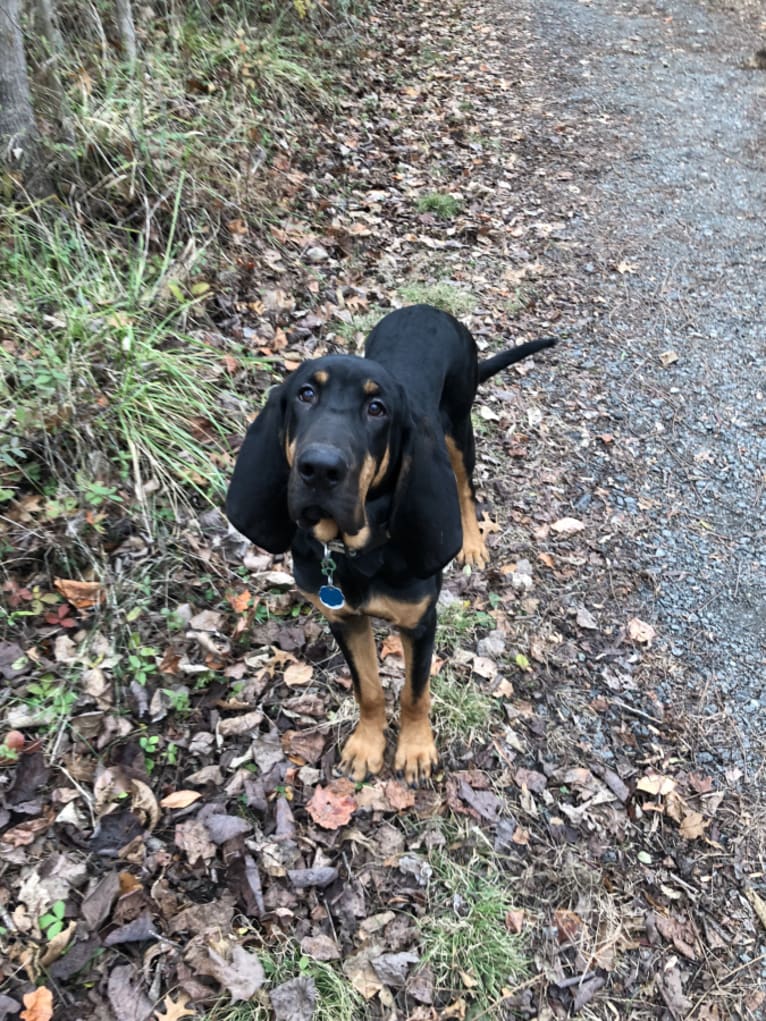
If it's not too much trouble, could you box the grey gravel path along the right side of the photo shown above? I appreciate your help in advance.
[500,0,766,776]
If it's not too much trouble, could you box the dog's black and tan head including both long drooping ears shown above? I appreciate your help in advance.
[227,355,461,577]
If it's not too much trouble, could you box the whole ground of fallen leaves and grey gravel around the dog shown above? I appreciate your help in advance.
[0,0,766,1021]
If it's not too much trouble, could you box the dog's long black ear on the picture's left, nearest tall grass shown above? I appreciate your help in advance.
[226,386,295,553]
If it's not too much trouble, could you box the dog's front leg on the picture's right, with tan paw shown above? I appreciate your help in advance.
[394,606,438,784]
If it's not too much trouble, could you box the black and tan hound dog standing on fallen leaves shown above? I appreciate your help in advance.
[227,305,556,783]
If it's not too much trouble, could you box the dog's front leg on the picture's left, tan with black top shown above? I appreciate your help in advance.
[330,616,386,780]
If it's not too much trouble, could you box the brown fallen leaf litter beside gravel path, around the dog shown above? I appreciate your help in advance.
[0,0,766,1021]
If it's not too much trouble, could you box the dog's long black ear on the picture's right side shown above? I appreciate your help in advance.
[389,421,463,578]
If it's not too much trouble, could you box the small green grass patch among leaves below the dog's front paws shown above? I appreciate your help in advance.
[419,834,530,1017]
